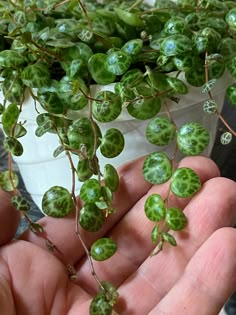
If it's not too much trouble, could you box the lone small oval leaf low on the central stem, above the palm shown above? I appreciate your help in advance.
[90,237,117,261]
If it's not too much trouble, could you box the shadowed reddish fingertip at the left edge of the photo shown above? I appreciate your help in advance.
[0,189,21,246]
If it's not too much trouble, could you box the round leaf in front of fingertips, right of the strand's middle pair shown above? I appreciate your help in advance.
[170,167,201,198]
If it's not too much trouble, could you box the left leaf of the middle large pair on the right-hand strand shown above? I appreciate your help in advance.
[143,152,172,184]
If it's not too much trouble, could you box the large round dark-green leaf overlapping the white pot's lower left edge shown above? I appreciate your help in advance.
[42,186,73,218]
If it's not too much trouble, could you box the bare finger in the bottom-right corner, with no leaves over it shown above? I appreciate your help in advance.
[149,228,236,315]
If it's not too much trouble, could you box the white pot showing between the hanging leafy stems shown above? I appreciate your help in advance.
[0,75,232,208]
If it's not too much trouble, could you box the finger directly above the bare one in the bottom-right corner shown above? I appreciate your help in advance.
[114,178,236,315]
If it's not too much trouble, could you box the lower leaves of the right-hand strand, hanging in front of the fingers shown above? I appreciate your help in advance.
[143,158,201,253]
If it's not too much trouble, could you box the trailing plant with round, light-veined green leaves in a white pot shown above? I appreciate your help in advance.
[0,0,236,314]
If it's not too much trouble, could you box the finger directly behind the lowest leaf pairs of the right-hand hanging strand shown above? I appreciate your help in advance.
[74,157,219,293]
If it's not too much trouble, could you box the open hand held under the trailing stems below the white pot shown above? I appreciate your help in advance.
[0,157,236,315]
